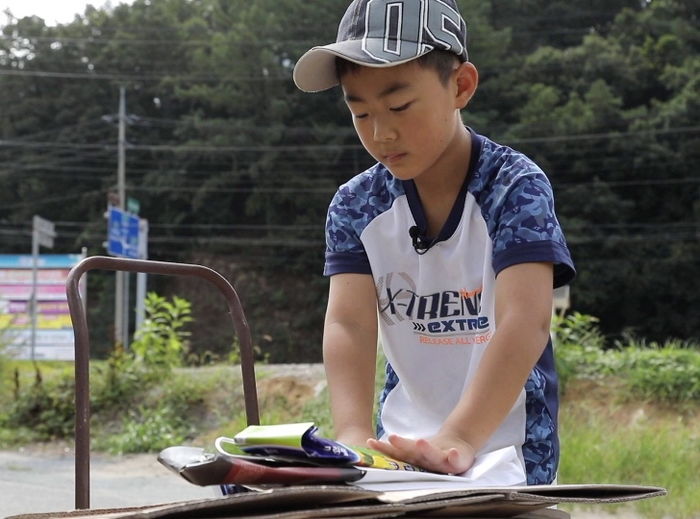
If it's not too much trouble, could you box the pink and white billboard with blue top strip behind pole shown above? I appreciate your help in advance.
[0,254,85,360]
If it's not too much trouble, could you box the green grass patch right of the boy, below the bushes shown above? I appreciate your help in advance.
[559,380,700,519]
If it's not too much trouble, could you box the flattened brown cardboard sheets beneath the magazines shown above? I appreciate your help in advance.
[7,485,666,519]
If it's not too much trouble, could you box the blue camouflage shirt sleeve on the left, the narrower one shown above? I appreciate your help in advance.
[323,185,372,276]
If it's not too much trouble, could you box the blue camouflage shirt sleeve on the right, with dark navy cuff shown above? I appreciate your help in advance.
[491,159,576,288]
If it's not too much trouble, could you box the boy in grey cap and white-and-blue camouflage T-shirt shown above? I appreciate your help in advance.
[294,0,574,484]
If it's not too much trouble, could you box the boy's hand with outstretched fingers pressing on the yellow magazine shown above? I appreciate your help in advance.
[367,432,476,474]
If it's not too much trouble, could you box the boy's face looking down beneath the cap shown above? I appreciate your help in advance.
[340,62,465,180]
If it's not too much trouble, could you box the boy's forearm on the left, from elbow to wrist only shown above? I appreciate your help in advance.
[323,324,377,445]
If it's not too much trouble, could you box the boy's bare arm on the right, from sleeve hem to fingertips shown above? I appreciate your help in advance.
[368,263,553,474]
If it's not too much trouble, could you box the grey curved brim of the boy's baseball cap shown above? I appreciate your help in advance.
[292,40,430,92]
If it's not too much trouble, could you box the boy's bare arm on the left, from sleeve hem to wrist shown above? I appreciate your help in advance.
[323,274,377,445]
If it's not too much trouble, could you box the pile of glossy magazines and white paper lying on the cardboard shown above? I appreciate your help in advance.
[158,422,526,491]
